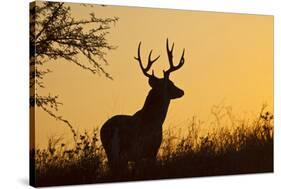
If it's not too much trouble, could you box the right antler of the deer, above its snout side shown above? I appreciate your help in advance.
[164,38,185,78]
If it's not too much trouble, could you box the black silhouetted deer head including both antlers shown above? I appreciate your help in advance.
[135,39,185,99]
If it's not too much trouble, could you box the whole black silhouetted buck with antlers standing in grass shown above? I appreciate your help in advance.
[100,39,184,170]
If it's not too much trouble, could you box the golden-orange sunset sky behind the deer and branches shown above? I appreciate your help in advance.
[35,4,273,147]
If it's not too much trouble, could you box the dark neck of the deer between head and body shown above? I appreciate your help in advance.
[136,89,170,126]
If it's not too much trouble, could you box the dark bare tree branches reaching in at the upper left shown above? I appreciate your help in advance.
[29,2,118,136]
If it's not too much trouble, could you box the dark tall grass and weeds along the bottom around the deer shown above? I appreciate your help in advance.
[32,109,273,186]
